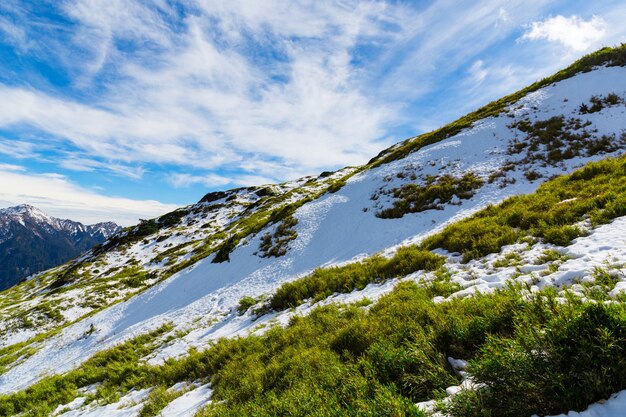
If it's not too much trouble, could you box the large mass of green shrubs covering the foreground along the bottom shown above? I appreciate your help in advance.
[0,282,626,417]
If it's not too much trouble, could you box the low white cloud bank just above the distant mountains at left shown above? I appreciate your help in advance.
[0,164,177,226]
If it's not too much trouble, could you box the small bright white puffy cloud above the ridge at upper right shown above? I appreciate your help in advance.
[521,15,606,52]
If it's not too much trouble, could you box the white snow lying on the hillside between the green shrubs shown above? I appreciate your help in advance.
[0,63,626,416]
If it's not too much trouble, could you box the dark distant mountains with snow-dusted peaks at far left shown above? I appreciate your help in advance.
[0,204,121,290]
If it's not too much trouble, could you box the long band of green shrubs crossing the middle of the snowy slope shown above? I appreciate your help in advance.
[268,156,626,310]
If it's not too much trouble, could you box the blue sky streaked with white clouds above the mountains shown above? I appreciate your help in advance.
[0,0,626,225]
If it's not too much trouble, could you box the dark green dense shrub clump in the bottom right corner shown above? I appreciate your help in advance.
[449,303,626,417]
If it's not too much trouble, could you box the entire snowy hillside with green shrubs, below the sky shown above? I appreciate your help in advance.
[0,45,626,417]
